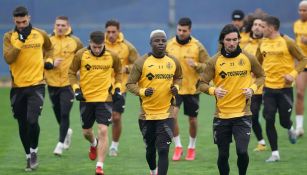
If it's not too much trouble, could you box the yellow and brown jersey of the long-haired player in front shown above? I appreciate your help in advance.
[198,52,264,119]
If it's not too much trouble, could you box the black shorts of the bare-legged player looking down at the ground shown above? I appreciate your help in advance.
[80,102,112,129]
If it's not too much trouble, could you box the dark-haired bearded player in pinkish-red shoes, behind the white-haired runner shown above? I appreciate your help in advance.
[166,18,209,161]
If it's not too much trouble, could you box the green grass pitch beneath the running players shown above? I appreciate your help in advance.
[0,88,307,175]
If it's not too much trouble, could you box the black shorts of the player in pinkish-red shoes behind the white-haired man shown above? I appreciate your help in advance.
[176,94,199,117]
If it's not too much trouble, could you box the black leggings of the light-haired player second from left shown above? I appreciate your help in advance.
[48,86,74,143]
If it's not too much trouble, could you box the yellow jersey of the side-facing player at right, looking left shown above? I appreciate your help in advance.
[256,35,307,89]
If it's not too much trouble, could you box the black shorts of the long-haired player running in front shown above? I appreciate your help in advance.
[213,116,252,146]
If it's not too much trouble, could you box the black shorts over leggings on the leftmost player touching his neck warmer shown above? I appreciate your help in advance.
[10,85,45,124]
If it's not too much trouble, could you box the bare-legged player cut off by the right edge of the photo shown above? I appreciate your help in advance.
[293,0,307,137]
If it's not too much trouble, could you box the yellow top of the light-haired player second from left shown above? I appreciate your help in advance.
[45,28,83,87]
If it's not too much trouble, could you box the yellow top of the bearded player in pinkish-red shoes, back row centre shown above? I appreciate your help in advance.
[166,37,210,95]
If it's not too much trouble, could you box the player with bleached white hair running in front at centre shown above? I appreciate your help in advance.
[126,30,182,175]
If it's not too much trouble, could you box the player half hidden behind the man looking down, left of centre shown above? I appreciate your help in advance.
[105,20,139,156]
